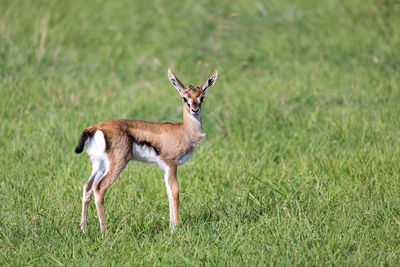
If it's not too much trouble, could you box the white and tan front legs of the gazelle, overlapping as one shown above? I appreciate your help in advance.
[163,164,179,232]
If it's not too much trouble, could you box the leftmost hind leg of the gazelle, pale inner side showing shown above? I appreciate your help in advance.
[81,160,106,232]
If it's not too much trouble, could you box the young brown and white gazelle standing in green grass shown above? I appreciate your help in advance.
[75,69,218,232]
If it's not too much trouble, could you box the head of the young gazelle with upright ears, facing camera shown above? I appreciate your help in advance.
[168,69,218,115]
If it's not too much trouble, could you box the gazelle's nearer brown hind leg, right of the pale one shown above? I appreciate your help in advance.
[93,156,130,234]
